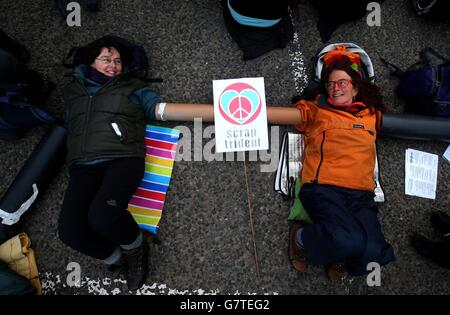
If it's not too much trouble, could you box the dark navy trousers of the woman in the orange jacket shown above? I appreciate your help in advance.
[300,184,395,275]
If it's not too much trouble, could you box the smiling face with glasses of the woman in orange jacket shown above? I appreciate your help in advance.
[326,70,358,105]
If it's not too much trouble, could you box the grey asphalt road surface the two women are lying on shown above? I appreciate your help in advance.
[0,0,450,295]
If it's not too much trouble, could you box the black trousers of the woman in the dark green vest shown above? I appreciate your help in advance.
[58,158,144,259]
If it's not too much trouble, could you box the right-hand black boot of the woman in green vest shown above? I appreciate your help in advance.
[122,239,149,291]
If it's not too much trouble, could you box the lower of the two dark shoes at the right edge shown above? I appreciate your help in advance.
[411,233,450,269]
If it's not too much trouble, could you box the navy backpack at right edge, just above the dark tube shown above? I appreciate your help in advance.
[382,47,450,117]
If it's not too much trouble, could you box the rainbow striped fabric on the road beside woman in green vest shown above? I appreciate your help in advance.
[128,125,180,234]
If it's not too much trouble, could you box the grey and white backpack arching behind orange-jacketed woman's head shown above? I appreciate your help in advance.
[292,43,375,103]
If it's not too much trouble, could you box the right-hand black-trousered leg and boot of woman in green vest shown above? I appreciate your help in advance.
[88,158,149,290]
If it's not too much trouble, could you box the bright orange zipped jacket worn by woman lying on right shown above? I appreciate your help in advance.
[294,96,381,191]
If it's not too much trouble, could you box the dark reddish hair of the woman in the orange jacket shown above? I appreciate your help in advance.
[322,60,386,112]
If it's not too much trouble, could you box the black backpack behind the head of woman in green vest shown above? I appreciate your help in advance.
[63,35,156,82]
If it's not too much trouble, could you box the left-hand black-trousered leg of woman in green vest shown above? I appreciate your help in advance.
[58,166,117,259]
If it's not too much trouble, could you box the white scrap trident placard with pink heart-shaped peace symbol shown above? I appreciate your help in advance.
[213,78,269,152]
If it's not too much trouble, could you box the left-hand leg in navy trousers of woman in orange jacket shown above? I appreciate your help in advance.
[300,184,366,265]
